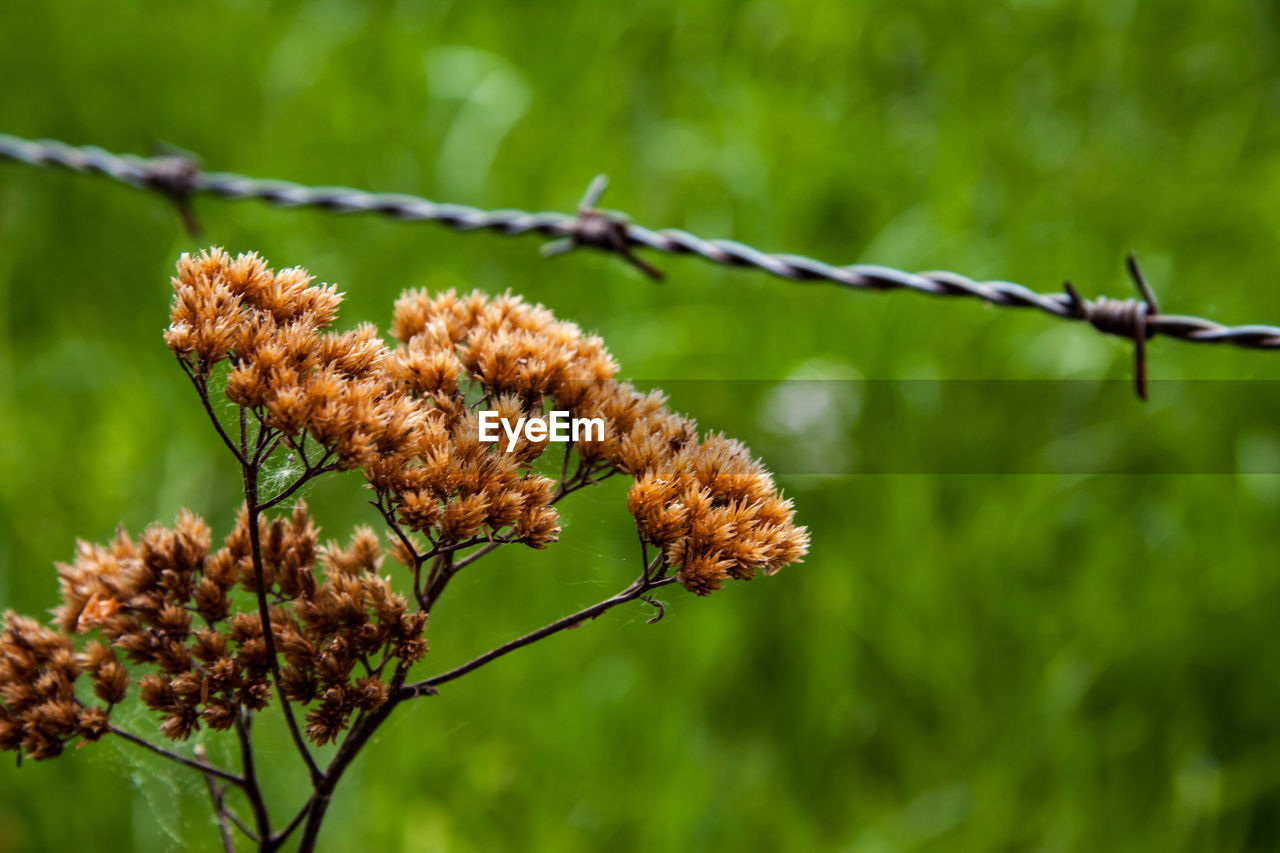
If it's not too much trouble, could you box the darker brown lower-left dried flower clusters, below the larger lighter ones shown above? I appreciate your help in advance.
[0,503,426,758]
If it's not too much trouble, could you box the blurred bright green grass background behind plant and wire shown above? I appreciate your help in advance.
[0,0,1280,852]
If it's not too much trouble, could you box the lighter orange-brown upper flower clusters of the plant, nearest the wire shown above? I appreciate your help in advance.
[166,242,808,594]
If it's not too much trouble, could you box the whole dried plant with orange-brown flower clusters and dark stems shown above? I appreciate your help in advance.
[0,248,808,850]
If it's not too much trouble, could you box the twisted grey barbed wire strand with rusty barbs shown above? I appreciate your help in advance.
[0,133,1280,400]
